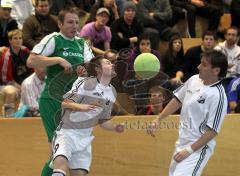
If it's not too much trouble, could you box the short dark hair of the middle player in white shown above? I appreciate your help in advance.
[87,55,105,77]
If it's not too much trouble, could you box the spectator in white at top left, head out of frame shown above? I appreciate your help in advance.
[11,0,34,29]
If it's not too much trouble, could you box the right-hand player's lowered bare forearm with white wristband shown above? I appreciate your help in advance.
[174,128,217,162]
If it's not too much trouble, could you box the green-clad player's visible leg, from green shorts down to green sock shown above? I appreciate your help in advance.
[39,98,61,176]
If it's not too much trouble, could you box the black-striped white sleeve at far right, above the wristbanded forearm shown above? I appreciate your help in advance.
[207,87,227,133]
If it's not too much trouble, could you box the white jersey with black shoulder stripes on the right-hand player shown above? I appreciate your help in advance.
[174,75,227,149]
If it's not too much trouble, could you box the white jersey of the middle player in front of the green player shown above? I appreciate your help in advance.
[56,77,116,136]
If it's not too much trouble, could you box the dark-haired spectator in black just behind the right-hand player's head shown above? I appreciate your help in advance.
[184,31,217,81]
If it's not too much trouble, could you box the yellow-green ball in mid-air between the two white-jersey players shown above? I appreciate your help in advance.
[134,53,160,79]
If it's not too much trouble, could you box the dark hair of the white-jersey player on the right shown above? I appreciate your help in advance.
[201,50,228,79]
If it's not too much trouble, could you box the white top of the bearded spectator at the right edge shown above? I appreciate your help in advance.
[214,41,240,77]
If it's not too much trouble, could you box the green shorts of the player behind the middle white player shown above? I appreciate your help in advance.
[39,98,61,142]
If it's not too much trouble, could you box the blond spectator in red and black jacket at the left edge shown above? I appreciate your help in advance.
[0,29,32,117]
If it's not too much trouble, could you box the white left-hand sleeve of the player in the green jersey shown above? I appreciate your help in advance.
[32,32,57,56]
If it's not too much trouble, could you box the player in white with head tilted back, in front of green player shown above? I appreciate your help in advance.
[52,56,124,176]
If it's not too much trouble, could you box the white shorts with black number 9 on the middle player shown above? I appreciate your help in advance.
[52,130,94,171]
